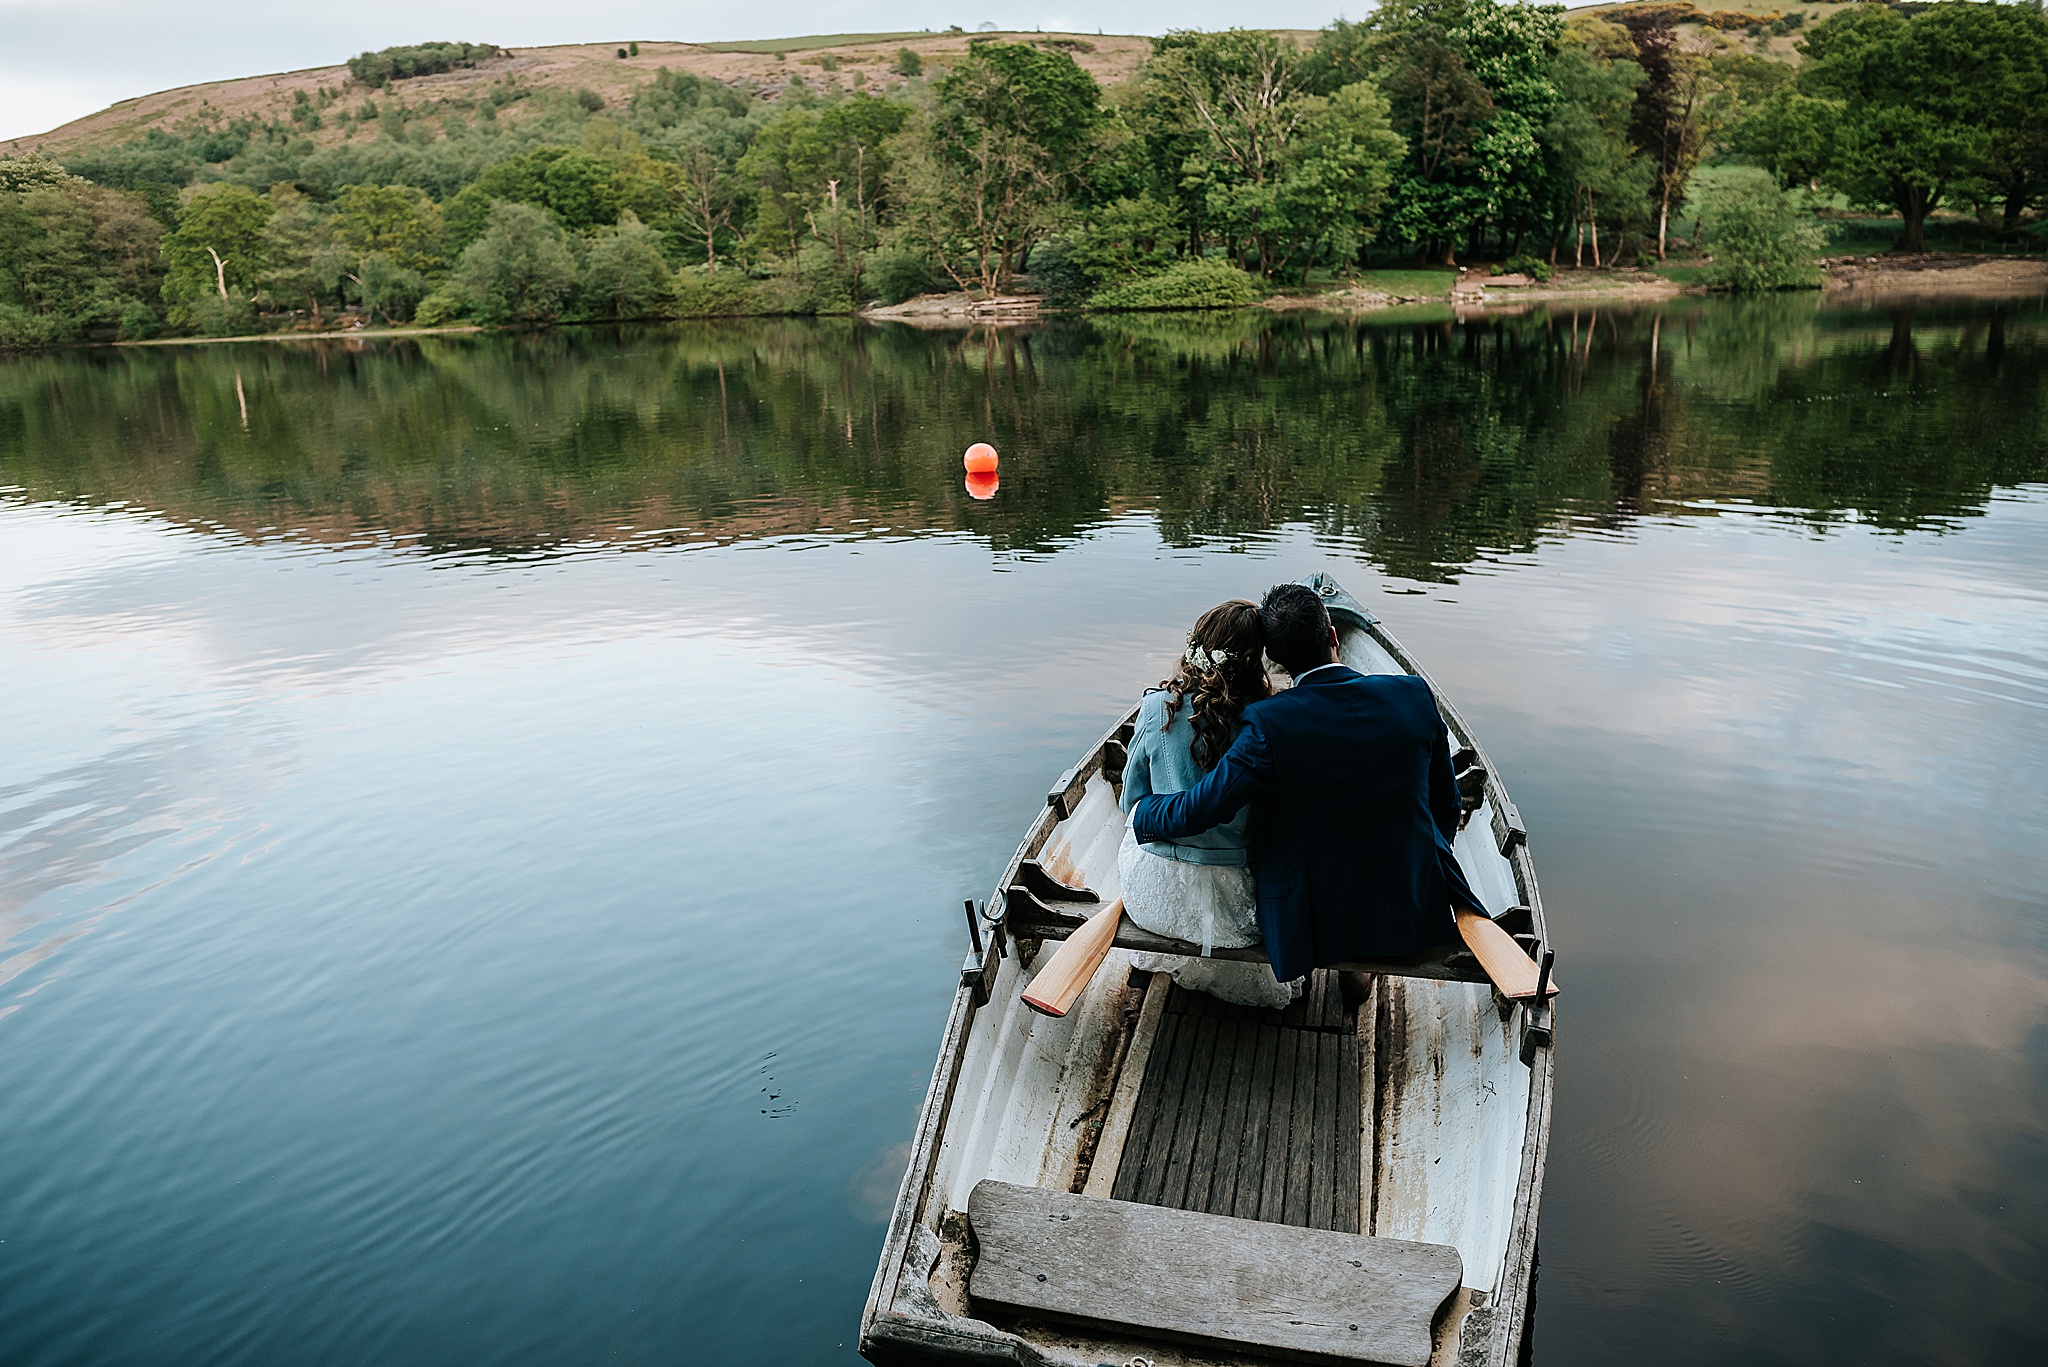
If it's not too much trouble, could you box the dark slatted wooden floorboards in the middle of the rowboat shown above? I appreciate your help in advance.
[1112,971,1364,1234]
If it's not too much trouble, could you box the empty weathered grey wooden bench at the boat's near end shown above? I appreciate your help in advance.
[967,1180,1464,1367]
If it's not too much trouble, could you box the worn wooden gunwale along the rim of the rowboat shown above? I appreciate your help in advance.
[858,615,1554,1367]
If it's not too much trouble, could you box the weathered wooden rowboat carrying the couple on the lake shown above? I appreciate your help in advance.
[860,576,1554,1367]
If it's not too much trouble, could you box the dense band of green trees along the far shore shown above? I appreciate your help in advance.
[0,0,2048,346]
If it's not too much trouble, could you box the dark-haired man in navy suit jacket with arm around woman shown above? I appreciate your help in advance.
[1130,584,1483,982]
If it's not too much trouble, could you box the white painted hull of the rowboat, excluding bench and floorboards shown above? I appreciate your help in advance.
[860,580,1552,1367]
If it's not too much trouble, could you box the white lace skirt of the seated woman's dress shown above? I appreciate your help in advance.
[1116,826,1300,1006]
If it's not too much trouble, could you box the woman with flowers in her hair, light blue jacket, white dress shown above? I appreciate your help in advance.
[1116,600,1300,1006]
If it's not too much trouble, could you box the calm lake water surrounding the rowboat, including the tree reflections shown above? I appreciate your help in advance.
[0,295,2048,1367]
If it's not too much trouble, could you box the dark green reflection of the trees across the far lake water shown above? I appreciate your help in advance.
[0,295,2048,580]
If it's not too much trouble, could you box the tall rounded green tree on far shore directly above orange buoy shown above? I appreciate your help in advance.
[893,43,1102,293]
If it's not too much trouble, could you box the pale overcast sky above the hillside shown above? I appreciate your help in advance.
[0,0,1368,139]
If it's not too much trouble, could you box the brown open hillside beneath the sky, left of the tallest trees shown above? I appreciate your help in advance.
[0,33,1151,160]
